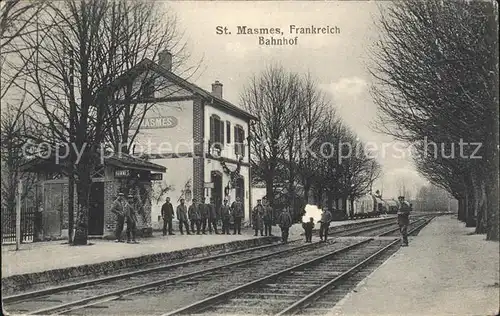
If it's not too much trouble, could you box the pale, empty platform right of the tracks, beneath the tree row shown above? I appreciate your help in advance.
[328,215,500,316]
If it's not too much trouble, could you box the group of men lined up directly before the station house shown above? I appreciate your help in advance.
[161,197,244,236]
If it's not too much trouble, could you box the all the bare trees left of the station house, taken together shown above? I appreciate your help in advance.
[0,0,197,245]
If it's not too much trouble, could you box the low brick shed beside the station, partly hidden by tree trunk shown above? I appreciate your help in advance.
[21,153,166,239]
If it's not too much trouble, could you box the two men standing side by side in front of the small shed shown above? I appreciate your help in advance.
[111,192,140,244]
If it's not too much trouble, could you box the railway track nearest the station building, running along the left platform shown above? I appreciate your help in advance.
[3,216,434,315]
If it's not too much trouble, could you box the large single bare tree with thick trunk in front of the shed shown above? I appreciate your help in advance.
[16,0,194,245]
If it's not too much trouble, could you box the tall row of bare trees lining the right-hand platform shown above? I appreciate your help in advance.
[371,0,499,240]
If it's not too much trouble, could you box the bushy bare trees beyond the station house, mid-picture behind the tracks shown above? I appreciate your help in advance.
[241,65,380,216]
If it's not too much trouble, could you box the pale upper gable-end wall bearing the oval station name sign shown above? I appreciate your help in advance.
[135,100,194,154]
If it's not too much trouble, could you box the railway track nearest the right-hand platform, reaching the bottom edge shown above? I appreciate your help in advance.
[162,220,429,316]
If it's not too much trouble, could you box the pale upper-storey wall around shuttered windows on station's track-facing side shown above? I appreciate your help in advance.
[204,104,249,162]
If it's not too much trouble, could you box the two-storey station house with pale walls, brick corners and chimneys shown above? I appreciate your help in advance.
[125,51,257,221]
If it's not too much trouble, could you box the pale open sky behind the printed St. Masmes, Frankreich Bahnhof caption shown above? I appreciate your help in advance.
[165,1,427,197]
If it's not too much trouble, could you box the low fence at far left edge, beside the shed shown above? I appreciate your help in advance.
[2,207,35,244]
